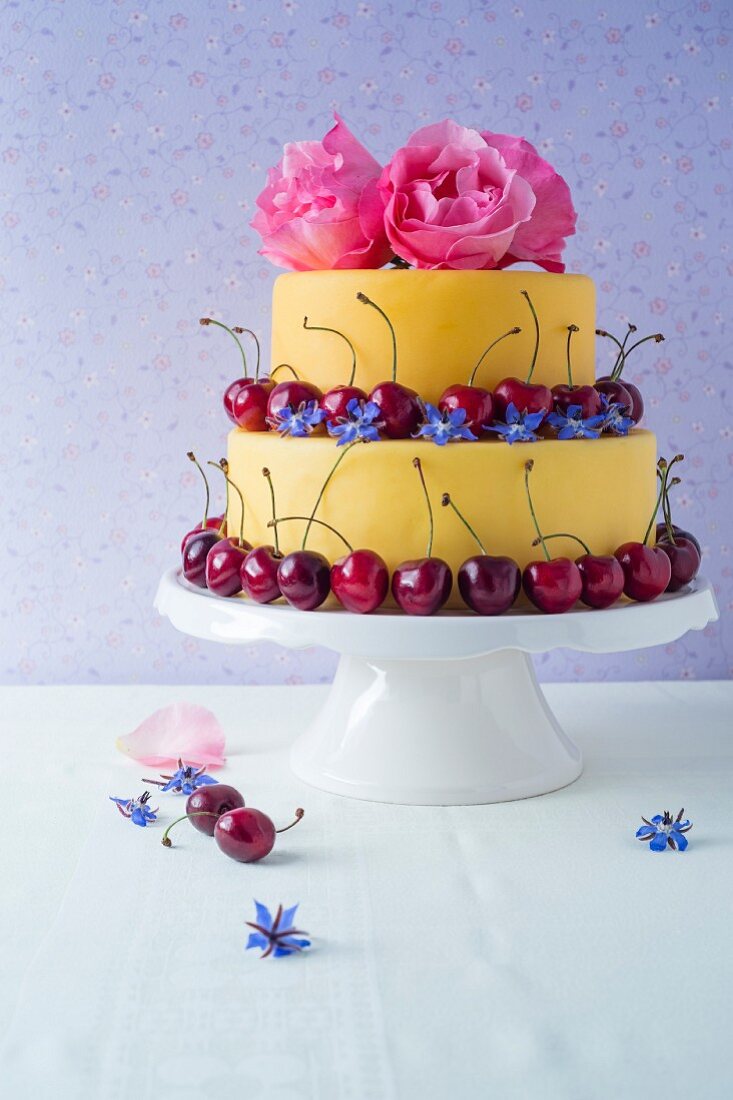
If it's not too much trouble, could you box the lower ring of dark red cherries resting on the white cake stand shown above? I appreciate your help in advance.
[180,441,701,615]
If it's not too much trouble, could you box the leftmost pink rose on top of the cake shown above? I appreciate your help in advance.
[252,114,392,272]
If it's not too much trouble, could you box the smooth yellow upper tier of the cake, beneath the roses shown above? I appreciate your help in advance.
[272,270,595,404]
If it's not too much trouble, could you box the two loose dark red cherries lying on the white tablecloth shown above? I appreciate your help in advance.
[161,783,305,864]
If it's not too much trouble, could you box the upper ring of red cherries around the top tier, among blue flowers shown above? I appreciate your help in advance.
[200,290,664,439]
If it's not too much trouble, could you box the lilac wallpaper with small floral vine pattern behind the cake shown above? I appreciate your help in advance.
[0,0,733,683]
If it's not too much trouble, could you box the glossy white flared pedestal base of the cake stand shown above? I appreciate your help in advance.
[291,649,582,805]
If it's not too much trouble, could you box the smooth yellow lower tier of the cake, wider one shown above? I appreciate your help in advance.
[228,429,657,608]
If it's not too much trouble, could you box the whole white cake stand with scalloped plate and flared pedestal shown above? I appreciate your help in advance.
[155,570,718,805]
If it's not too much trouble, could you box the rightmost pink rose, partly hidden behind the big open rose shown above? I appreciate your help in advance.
[481,130,578,272]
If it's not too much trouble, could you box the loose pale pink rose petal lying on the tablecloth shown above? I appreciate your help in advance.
[117,703,226,768]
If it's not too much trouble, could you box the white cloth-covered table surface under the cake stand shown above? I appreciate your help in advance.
[0,683,733,1100]
